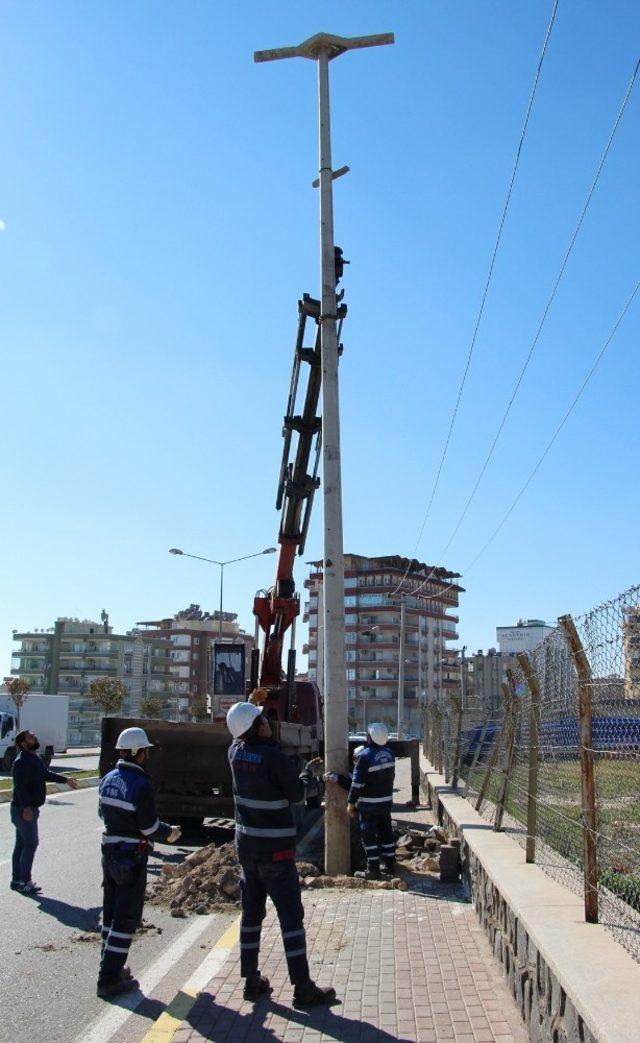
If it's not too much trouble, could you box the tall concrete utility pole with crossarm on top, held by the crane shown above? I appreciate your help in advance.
[253,32,394,875]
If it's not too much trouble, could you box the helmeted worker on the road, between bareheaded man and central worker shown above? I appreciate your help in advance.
[97,728,180,999]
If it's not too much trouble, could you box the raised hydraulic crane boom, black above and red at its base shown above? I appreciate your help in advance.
[251,283,348,715]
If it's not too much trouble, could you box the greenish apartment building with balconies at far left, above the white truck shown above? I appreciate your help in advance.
[11,615,178,746]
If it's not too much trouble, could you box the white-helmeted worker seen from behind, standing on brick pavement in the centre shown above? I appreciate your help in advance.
[226,702,336,1006]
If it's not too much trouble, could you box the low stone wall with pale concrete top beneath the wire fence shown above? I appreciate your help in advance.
[423,763,640,1043]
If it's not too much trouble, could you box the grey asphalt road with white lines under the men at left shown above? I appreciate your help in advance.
[0,788,236,1043]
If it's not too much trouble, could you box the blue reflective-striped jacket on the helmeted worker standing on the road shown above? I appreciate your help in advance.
[98,760,171,850]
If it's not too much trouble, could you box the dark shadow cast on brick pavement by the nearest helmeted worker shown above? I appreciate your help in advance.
[186,992,412,1043]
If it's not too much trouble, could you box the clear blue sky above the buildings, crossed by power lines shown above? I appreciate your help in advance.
[0,0,640,672]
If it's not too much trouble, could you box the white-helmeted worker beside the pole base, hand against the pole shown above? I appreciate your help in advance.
[347,722,395,880]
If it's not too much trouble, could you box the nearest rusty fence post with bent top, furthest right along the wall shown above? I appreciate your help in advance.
[558,615,598,923]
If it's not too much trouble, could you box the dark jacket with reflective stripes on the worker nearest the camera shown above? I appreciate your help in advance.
[229,737,304,862]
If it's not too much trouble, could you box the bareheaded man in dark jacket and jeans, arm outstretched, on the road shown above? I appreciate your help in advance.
[10,730,78,895]
